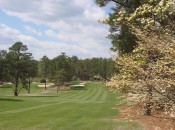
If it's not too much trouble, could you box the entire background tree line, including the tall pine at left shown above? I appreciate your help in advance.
[0,42,116,96]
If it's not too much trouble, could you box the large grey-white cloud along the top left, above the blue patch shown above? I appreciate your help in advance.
[0,0,83,24]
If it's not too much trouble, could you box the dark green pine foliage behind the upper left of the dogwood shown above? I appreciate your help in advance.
[96,0,143,54]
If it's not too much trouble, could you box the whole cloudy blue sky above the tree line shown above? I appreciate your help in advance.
[0,0,111,59]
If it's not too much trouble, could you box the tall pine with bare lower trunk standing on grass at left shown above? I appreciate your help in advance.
[7,42,32,96]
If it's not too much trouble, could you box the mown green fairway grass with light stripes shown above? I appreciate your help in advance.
[0,82,141,130]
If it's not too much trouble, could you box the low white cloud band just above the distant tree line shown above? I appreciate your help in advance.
[0,24,110,59]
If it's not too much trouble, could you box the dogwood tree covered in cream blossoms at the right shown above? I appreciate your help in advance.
[103,0,175,116]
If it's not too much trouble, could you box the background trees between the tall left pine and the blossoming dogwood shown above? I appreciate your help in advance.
[38,53,116,84]
